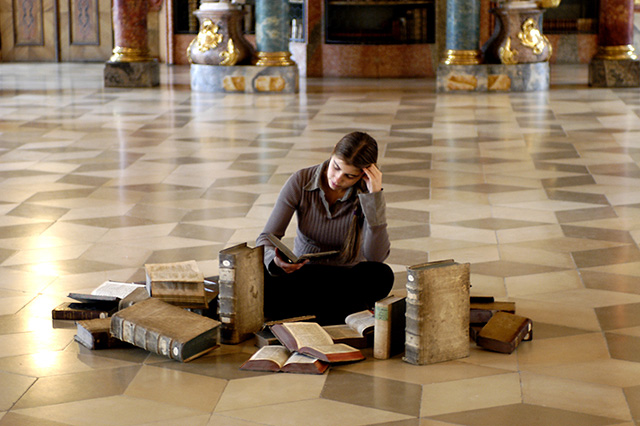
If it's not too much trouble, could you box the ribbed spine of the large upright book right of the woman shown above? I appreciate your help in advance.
[403,269,424,365]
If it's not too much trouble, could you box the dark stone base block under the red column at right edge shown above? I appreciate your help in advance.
[589,58,640,87]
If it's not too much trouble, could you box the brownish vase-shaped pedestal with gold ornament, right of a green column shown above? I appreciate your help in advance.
[483,1,552,65]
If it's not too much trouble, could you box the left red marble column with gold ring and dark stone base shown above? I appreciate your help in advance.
[104,0,162,87]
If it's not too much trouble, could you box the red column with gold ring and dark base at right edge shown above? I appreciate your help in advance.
[589,0,640,87]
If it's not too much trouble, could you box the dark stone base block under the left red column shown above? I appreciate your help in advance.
[104,59,160,87]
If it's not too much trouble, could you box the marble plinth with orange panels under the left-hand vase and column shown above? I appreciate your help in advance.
[191,64,299,94]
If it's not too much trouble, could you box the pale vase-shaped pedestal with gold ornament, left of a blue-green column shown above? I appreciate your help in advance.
[187,1,255,66]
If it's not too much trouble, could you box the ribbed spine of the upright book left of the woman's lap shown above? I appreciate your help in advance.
[218,253,239,344]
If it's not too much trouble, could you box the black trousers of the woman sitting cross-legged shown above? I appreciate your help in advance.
[264,262,394,325]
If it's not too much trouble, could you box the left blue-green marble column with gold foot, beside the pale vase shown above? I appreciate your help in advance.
[255,0,295,66]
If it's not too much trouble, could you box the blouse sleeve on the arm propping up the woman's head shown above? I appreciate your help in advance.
[358,191,391,262]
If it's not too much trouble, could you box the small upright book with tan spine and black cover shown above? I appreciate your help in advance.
[373,295,407,359]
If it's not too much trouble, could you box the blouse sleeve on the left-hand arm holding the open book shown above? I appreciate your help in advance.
[256,173,302,271]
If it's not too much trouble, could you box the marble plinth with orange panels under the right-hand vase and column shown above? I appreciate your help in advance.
[436,62,549,92]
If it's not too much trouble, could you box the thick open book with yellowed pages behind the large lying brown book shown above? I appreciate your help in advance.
[144,260,208,309]
